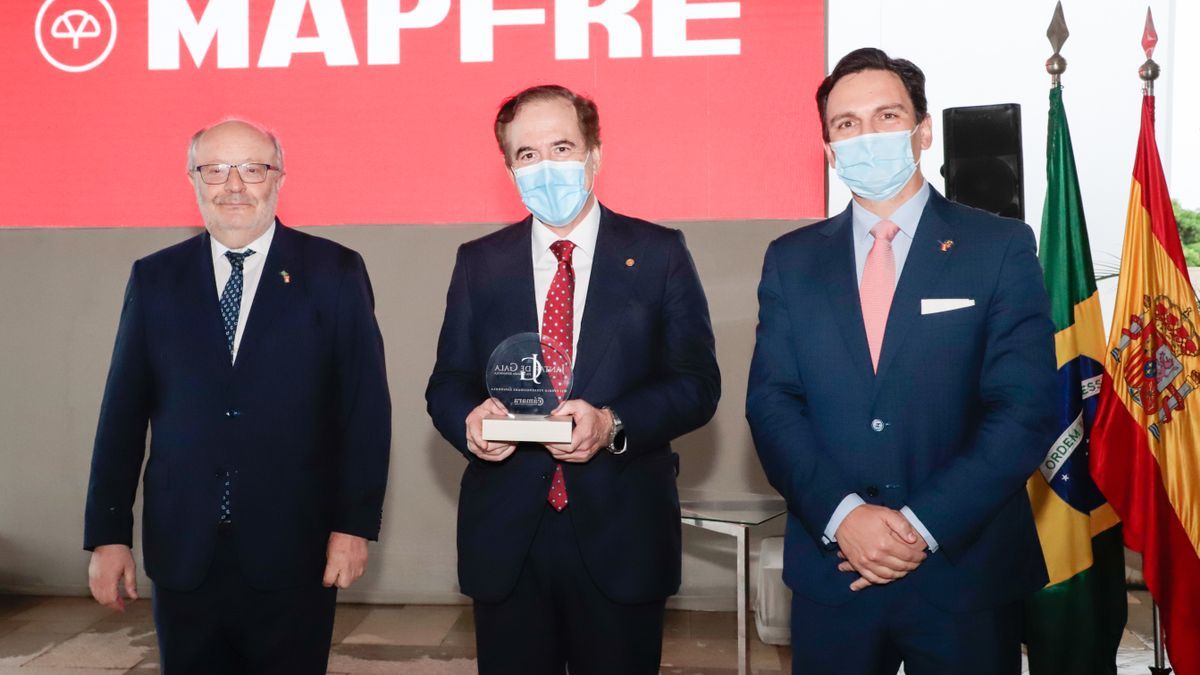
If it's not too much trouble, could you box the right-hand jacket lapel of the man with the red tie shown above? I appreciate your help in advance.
[571,204,643,399]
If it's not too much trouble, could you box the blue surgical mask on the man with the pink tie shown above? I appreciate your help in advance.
[829,127,919,202]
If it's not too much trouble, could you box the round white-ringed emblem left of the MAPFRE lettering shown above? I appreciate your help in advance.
[34,0,116,72]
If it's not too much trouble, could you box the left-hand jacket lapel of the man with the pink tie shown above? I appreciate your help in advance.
[822,208,874,382]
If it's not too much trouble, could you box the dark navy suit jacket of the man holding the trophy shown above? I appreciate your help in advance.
[426,207,720,603]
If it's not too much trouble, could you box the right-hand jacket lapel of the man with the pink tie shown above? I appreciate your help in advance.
[876,189,953,392]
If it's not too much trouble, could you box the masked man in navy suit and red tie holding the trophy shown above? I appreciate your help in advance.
[426,85,720,675]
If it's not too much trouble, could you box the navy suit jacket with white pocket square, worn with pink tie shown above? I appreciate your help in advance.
[746,187,1056,611]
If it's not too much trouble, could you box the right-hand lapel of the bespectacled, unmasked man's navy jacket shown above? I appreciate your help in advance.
[234,220,305,368]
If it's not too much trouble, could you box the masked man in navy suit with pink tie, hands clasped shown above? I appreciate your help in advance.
[746,49,1055,675]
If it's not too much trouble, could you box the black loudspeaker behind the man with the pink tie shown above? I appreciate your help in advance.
[942,103,1025,220]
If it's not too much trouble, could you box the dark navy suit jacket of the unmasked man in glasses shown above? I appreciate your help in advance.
[84,222,391,591]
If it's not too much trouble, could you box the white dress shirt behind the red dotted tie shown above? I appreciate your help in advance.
[530,201,600,363]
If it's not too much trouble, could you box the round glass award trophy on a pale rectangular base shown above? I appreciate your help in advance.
[484,333,575,443]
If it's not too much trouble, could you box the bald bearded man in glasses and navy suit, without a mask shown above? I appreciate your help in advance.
[84,120,391,674]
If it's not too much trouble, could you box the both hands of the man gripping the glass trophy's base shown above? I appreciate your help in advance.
[467,398,613,464]
